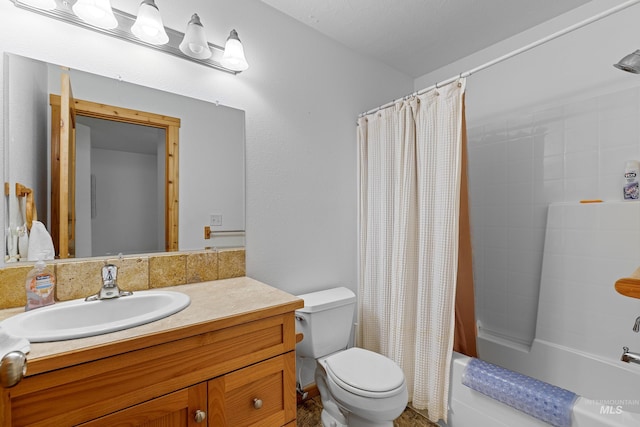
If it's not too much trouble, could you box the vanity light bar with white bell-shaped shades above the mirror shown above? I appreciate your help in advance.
[9,0,249,74]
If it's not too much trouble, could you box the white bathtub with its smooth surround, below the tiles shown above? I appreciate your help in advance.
[441,202,640,427]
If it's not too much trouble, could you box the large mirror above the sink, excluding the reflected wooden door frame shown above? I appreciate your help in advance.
[3,54,245,261]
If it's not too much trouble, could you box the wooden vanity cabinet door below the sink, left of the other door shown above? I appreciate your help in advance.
[80,383,207,427]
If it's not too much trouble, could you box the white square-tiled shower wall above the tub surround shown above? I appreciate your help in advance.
[468,87,640,345]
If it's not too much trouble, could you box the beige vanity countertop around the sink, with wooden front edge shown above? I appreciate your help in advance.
[0,277,304,376]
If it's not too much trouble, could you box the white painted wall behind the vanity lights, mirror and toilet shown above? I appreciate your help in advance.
[0,0,413,293]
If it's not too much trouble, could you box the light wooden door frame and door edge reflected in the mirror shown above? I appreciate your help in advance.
[49,73,180,258]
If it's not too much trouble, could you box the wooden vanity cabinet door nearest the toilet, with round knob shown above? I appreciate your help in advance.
[208,352,296,427]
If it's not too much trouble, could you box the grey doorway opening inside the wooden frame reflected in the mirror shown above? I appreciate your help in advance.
[75,115,166,257]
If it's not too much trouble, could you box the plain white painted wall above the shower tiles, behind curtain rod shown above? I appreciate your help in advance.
[414,0,640,121]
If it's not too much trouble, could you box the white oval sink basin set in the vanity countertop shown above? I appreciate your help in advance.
[0,291,191,342]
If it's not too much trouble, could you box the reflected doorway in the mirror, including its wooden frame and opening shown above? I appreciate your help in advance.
[50,88,180,258]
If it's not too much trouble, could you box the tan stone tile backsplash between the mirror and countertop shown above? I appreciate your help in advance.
[0,248,245,309]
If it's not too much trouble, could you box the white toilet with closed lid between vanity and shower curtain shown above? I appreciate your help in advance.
[296,287,408,427]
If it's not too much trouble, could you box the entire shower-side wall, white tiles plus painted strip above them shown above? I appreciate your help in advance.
[415,0,640,346]
